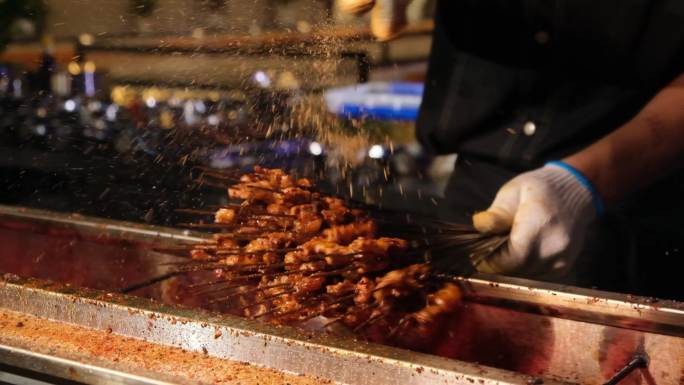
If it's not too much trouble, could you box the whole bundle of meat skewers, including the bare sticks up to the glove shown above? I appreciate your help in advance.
[144,167,506,339]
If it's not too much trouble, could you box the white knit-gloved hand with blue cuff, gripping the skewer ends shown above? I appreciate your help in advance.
[473,162,603,279]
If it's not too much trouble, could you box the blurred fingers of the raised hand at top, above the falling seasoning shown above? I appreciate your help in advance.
[338,0,411,41]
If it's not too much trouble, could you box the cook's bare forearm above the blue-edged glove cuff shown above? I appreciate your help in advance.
[564,74,684,202]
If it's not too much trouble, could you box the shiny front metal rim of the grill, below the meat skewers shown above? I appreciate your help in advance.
[0,277,548,384]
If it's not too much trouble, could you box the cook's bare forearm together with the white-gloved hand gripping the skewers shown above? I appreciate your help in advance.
[473,74,684,278]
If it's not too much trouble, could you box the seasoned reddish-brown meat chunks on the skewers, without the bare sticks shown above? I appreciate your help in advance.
[190,167,461,342]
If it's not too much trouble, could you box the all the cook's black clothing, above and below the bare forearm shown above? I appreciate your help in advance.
[417,0,684,299]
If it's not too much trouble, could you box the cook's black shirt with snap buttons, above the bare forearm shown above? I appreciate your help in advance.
[418,0,684,170]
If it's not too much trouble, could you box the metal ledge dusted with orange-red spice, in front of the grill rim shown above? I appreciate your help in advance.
[0,309,330,385]
